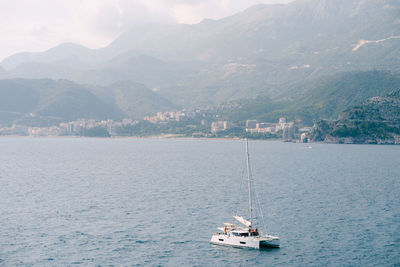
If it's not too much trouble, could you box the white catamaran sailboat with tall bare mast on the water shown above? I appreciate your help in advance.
[210,139,280,249]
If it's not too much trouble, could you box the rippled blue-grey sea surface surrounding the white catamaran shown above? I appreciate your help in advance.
[0,138,400,266]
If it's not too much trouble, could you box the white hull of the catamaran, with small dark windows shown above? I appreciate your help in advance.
[210,234,280,249]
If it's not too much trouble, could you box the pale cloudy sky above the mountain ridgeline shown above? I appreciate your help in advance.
[0,0,293,61]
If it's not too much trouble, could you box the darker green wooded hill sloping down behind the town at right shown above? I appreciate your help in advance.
[220,71,400,125]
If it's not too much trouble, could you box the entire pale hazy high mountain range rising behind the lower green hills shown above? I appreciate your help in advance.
[0,0,400,126]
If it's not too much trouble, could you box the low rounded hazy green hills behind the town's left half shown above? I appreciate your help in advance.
[0,79,178,125]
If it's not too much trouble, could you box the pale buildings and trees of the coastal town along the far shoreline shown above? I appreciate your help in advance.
[0,109,312,142]
